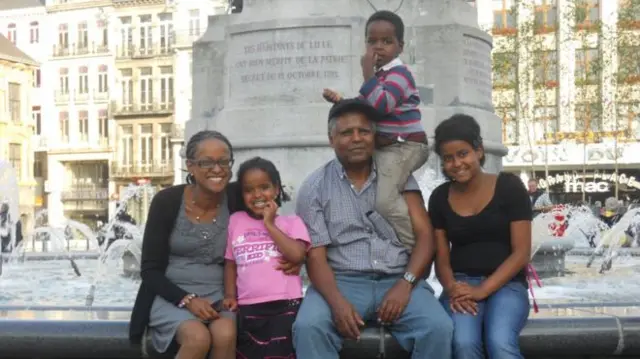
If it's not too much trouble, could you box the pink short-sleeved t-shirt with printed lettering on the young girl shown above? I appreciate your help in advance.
[224,212,311,305]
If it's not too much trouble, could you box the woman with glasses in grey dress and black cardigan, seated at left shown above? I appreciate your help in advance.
[129,131,299,359]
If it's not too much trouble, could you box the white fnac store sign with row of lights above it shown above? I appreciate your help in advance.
[538,172,640,193]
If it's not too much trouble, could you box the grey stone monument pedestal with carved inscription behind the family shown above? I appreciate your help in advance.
[185,0,506,205]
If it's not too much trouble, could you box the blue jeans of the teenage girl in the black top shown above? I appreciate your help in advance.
[440,274,529,359]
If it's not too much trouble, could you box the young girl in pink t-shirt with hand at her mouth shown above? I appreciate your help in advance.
[223,157,310,359]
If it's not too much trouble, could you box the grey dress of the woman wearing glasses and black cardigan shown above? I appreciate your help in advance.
[149,200,231,353]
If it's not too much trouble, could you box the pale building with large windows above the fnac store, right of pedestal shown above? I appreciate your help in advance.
[476,0,640,202]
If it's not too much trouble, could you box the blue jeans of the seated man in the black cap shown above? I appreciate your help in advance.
[293,274,453,359]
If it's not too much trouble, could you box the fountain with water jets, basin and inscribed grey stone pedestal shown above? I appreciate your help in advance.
[0,0,640,359]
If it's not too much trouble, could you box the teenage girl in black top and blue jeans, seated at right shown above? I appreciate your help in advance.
[429,115,532,359]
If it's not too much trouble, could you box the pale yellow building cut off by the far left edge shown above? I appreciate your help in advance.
[0,34,38,232]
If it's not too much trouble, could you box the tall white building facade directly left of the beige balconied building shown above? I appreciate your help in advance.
[41,0,115,228]
